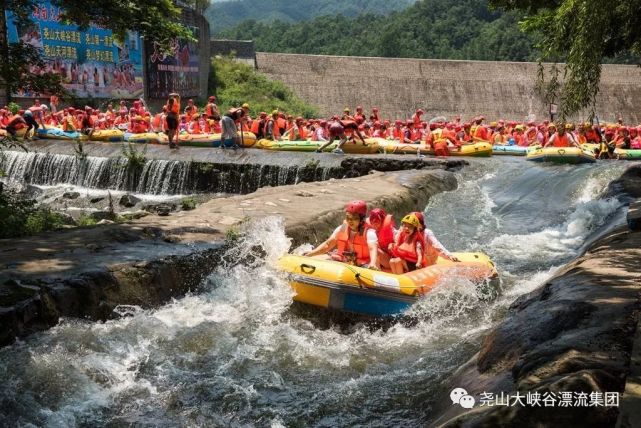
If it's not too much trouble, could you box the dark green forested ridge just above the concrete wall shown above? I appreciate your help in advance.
[220,0,537,61]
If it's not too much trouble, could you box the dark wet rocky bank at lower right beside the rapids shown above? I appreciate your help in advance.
[433,166,641,427]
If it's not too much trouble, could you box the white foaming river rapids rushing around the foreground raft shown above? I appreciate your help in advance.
[0,157,624,427]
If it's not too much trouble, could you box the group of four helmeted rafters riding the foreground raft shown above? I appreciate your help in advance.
[304,200,459,274]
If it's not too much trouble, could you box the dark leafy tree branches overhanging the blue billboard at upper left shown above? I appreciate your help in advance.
[0,0,195,101]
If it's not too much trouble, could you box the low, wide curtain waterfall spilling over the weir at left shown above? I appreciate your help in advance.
[0,151,344,195]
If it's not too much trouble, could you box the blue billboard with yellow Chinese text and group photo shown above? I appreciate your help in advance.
[6,1,143,98]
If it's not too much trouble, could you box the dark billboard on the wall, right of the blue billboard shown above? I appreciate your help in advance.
[146,27,200,98]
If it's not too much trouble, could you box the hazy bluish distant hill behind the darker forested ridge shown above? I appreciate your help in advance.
[204,0,415,33]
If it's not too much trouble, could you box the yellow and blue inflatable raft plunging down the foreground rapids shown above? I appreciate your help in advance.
[278,253,498,317]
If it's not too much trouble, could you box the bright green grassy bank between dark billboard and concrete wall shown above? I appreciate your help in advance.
[209,58,318,118]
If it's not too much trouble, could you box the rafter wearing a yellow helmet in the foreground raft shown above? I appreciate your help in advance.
[389,214,426,275]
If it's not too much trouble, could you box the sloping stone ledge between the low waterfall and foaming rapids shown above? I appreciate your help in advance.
[0,145,465,345]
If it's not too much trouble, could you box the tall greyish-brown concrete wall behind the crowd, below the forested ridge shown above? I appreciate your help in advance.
[256,52,641,123]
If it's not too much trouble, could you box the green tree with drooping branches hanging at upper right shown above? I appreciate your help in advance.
[490,0,641,118]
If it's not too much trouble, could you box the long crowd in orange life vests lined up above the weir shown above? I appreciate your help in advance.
[0,94,641,157]
